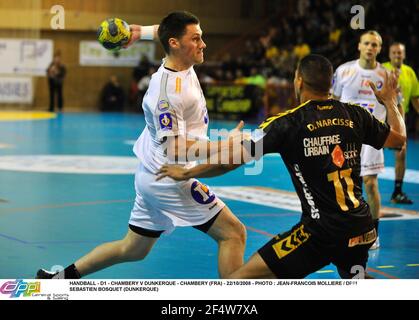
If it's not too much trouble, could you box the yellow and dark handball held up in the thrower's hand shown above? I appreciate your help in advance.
[97,18,131,51]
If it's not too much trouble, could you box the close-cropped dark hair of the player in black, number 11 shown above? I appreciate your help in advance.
[297,54,333,93]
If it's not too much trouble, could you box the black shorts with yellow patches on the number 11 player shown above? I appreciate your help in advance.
[258,223,377,279]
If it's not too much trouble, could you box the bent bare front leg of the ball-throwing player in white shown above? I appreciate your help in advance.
[208,206,246,278]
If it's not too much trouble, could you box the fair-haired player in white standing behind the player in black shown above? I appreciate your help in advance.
[332,31,388,249]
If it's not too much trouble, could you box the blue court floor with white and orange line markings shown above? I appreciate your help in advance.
[0,113,419,279]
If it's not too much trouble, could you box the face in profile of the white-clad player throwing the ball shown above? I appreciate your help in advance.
[179,24,207,65]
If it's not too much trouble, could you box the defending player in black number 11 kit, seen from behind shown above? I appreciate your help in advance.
[158,55,406,278]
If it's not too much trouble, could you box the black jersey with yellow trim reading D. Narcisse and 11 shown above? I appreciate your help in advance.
[253,99,390,238]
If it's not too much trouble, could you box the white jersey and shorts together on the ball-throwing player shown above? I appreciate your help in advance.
[129,65,225,233]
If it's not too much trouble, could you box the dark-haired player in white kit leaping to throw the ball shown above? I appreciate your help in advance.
[37,12,246,279]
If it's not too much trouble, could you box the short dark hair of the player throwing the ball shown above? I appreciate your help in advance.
[158,11,199,54]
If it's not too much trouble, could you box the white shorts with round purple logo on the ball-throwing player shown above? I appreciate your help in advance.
[129,164,225,233]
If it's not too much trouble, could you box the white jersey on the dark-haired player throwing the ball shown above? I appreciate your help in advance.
[133,64,208,173]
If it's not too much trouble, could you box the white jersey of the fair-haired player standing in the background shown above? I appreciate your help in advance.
[332,59,387,121]
